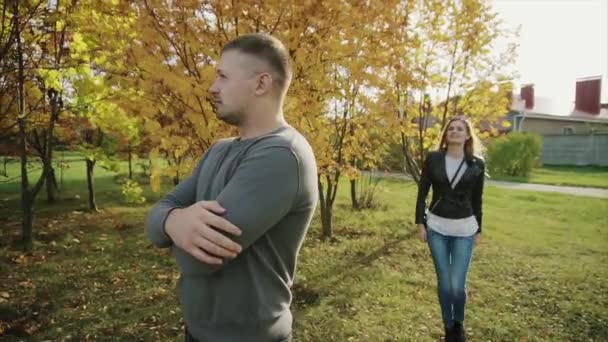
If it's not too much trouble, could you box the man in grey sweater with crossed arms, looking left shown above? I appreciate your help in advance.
[147,34,318,342]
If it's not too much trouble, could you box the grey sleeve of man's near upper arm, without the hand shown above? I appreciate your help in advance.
[216,146,300,250]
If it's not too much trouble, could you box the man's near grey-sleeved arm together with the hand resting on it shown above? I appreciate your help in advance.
[152,147,299,274]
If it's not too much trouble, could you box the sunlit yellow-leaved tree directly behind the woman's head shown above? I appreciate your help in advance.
[385,0,515,181]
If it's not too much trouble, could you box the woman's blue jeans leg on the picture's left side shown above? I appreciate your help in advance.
[427,229,454,329]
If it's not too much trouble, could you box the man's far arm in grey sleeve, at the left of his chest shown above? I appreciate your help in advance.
[146,155,207,247]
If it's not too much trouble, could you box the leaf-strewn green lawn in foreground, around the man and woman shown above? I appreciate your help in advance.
[0,159,608,342]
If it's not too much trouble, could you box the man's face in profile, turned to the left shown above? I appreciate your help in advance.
[209,50,257,126]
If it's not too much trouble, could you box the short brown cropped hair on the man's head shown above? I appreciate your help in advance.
[222,33,291,94]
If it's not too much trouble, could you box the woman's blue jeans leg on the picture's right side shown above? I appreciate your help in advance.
[449,236,475,323]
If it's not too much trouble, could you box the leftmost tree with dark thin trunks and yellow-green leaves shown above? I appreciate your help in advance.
[0,1,135,249]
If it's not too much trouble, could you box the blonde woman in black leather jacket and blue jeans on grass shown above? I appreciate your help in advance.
[416,116,485,341]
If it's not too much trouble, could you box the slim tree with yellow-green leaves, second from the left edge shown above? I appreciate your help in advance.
[64,2,140,211]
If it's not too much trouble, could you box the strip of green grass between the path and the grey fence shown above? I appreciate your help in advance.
[492,166,608,189]
